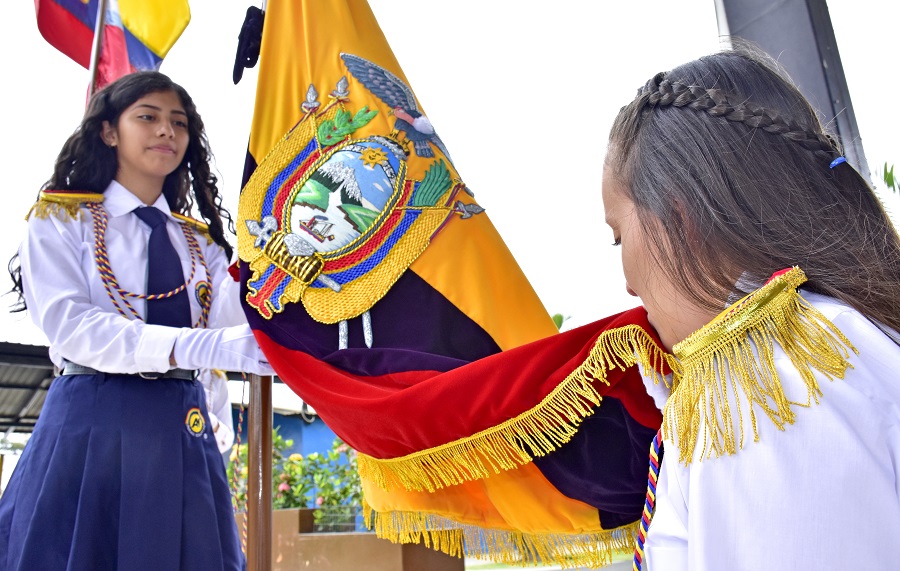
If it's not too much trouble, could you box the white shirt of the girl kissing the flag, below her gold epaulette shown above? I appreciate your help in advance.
[644,293,900,571]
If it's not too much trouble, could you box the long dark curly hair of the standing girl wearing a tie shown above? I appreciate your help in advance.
[9,71,234,311]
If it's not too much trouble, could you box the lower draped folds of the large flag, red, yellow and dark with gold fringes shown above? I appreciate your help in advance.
[250,308,668,566]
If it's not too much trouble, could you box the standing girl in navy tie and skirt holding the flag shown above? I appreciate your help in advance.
[0,72,272,571]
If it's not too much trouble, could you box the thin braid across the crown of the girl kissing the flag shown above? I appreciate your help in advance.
[638,72,841,159]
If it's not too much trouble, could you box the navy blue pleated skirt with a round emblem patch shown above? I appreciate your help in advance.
[0,373,246,571]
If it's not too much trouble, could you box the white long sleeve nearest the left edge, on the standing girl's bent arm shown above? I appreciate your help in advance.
[19,213,178,373]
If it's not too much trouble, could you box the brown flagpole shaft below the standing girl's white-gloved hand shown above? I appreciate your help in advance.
[247,375,272,571]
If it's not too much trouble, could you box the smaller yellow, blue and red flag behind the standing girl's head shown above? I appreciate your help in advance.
[34,0,191,87]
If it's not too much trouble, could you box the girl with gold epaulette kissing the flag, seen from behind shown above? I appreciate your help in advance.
[603,47,900,571]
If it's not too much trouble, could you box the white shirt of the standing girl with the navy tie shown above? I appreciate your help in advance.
[19,181,246,373]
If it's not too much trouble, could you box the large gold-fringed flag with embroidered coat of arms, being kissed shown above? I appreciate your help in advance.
[238,0,666,566]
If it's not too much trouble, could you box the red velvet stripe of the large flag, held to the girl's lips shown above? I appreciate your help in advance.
[256,308,662,459]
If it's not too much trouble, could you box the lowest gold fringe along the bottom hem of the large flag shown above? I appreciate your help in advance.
[363,501,638,568]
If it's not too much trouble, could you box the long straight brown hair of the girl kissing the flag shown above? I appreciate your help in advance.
[606,45,900,336]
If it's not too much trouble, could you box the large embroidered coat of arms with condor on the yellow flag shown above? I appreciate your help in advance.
[238,54,483,323]
